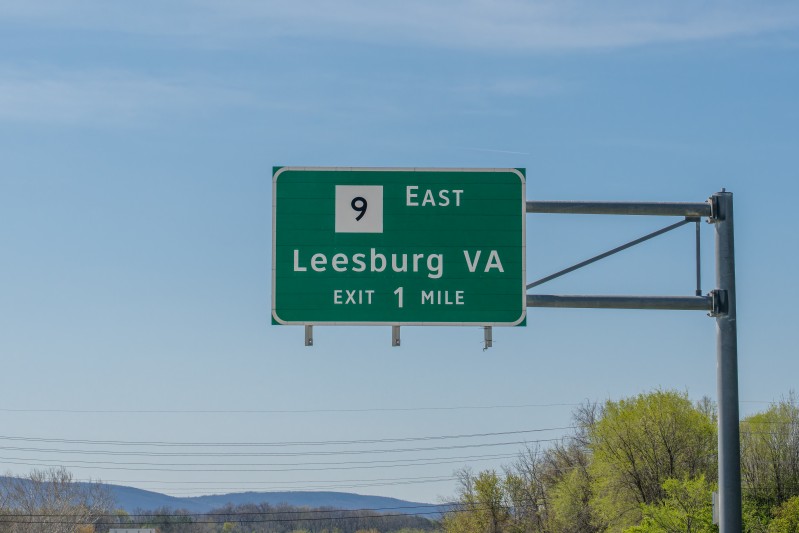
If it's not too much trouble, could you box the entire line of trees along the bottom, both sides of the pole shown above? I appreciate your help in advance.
[0,390,799,533]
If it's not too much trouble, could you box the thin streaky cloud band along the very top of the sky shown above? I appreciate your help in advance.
[0,0,799,50]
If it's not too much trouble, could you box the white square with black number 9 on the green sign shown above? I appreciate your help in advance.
[336,185,383,233]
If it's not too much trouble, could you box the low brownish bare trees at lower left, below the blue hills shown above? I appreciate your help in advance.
[0,468,439,533]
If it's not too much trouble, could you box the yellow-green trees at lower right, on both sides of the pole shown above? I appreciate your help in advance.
[443,391,799,533]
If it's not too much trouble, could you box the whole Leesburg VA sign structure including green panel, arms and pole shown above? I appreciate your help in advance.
[272,172,743,533]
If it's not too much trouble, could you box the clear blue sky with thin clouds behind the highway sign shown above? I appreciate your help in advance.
[0,0,799,502]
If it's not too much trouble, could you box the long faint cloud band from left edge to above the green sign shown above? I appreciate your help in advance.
[0,64,570,127]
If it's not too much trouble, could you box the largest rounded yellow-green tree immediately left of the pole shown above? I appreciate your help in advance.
[589,390,716,531]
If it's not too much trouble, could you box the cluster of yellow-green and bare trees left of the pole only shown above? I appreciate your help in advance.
[443,391,728,533]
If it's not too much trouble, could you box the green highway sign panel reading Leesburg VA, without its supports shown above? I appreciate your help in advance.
[272,167,527,326]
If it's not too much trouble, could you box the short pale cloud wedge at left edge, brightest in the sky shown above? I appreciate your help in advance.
[0,68,246,126]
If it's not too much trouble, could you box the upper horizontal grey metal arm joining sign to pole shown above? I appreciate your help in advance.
[527,200,712,217]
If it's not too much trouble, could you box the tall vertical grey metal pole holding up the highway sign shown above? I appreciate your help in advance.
[712,189,743,533]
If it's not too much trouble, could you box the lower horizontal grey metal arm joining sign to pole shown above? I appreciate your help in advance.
[527,294,713,312]
